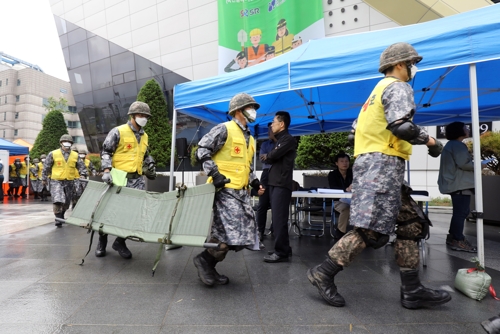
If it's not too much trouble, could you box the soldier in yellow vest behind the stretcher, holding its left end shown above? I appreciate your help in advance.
[95,101,156,259]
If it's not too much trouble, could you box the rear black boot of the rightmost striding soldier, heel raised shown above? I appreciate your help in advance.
[307,258,345,307]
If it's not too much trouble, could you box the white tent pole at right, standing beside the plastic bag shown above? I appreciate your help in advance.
[469,64,484,267]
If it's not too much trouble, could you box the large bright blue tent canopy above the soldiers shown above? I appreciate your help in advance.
[174,5,500,138]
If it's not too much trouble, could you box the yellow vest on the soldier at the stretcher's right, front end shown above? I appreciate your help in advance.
[207,121,255,189]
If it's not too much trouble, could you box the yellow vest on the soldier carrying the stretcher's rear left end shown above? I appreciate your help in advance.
[111,123,148,174]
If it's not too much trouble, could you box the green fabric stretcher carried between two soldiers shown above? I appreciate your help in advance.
[65,181,217,267]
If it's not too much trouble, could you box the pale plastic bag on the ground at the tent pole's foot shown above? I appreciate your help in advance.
[455,268,491,300]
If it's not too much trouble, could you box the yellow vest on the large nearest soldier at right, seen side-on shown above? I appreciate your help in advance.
[354,77,412,160]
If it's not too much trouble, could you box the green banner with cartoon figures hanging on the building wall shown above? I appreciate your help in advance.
[218,0,325,74]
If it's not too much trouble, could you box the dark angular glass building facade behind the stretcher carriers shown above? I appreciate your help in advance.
[54,15,195,153]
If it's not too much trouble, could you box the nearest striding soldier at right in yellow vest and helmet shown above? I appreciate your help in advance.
[307,43,451,309]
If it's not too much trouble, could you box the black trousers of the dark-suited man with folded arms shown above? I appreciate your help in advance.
[268,186,292,257]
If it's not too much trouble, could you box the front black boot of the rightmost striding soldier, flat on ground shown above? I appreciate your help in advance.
[401,270,451,309]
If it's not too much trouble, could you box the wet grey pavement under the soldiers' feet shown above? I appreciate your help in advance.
[0,199,500,334]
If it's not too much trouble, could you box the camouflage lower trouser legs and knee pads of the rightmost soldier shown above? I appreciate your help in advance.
[328,223,422,269]
